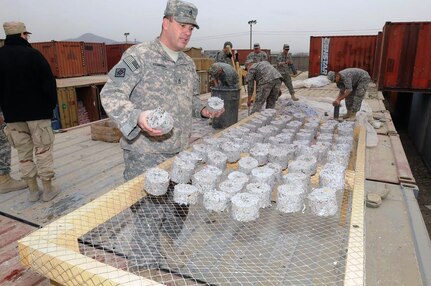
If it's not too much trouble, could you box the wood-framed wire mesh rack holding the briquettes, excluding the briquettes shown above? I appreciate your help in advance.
[20,105,363,285]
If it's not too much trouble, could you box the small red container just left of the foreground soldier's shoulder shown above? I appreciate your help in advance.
[81,42,108,75]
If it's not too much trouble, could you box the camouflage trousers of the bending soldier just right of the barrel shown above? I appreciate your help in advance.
[251,79,281,113]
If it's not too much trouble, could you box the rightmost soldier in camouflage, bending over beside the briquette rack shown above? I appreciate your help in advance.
[328,68,371,120]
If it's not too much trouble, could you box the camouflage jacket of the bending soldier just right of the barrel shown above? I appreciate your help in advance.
[246,61,283,95]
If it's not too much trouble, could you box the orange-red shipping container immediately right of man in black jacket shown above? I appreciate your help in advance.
[31,41,86,78]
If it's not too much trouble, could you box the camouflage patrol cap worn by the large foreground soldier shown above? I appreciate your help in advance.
[165,0,199,29]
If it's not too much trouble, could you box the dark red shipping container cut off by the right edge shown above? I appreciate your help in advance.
[379,22,431,93]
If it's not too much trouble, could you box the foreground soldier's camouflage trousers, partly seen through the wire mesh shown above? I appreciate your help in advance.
[123,150,187,269]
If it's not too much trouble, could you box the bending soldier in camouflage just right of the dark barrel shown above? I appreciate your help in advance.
[246,60,282,113]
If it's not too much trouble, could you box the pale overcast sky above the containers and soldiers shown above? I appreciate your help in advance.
[0,0,431,53]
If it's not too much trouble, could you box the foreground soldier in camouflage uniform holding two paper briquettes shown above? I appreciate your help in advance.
[101,0,223,268]
